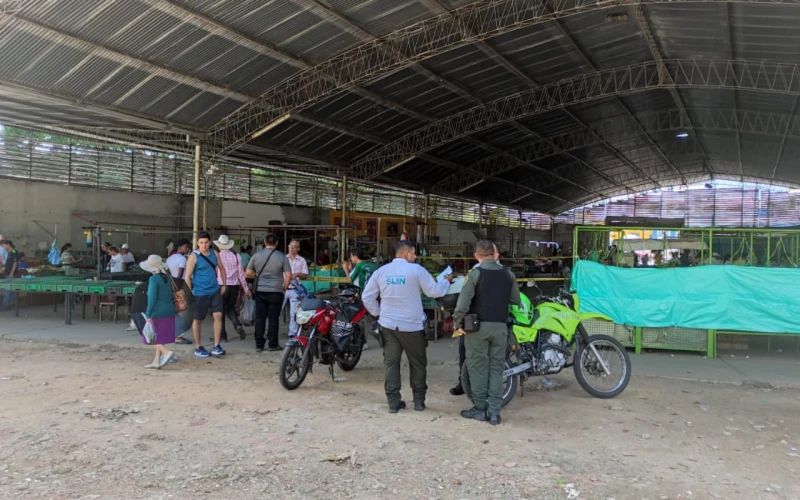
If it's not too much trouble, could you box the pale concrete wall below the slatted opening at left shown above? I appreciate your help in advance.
[0,179,329,255]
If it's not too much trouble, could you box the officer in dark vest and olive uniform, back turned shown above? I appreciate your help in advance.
[453,241,520,425]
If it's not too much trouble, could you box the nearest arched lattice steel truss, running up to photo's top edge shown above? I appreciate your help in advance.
[209,0,798,158]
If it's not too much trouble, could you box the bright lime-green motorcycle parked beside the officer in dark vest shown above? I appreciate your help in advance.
[461,282,631,406]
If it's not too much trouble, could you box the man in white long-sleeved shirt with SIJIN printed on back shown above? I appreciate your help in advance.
[361,241,450,413]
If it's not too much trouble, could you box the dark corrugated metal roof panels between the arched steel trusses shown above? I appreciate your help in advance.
[0,0,800,213]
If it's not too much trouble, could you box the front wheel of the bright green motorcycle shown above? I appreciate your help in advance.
[573,335,631,399]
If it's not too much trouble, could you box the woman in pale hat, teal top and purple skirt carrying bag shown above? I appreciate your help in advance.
[136,255,175,369]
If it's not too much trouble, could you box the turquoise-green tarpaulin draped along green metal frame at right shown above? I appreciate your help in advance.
[572,260,800,334]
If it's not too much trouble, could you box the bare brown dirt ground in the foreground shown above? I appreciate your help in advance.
[0,341,800,500]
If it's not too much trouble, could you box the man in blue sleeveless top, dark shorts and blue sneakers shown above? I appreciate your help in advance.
[184,232,228,358]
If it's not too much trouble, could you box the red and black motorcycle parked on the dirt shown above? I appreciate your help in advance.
[278,285,367,391]
